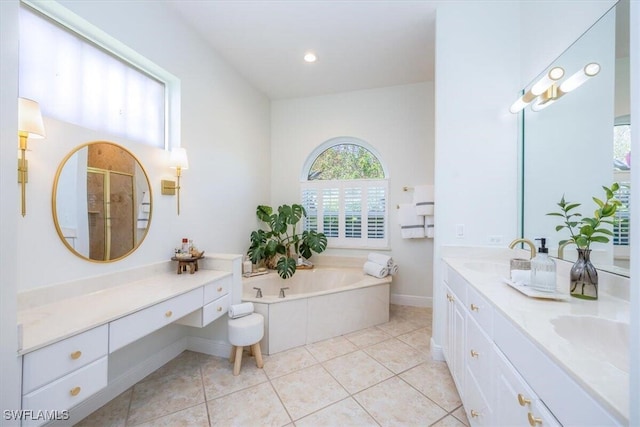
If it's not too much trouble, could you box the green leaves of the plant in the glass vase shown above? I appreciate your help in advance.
[547,182,621,250]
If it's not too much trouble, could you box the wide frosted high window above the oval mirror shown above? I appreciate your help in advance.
[19,0,179,148]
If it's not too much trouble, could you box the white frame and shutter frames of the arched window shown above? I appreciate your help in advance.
[300,137,389,249]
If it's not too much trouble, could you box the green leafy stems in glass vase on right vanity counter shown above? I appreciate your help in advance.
[547,182,621,300]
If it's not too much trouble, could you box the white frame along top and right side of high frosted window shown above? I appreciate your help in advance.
[20,0,181,150]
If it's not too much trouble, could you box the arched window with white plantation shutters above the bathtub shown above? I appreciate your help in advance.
[301,137,389,248]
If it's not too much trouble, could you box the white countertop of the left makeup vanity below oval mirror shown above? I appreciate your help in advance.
[18,255,239,354]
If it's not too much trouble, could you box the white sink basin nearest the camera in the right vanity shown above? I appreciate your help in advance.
[551,316,629,372]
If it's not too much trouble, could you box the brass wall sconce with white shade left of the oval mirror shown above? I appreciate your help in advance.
[18,98,45,216]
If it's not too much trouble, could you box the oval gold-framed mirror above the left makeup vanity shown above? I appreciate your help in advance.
[52,141,152,262]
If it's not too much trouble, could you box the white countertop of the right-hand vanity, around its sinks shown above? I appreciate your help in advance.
[443,248,629,423]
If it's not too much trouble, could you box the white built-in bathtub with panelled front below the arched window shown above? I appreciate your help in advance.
[242,267,391,354]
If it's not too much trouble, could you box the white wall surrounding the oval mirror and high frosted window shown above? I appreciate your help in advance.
[18,1,270,290]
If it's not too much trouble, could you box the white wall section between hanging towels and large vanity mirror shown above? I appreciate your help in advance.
[432,1,520,357]
